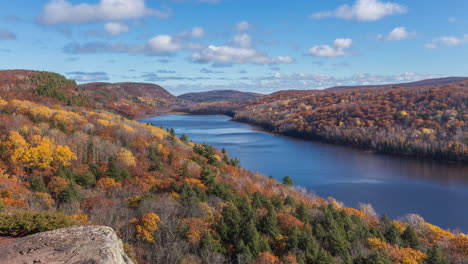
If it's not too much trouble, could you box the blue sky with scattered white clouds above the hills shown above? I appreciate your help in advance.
[0,0,468,95]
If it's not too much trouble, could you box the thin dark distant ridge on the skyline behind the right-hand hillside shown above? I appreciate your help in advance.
[325,77,468,91]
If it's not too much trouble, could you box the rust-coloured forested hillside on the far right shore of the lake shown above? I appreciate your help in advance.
[226,81,468,162]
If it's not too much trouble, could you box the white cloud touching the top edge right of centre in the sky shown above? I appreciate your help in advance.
[310,0,407,21]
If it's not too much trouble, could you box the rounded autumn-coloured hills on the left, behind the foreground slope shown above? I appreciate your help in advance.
[0,70,182,118]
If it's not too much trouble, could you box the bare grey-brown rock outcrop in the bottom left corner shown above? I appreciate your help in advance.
[0,226,133,264]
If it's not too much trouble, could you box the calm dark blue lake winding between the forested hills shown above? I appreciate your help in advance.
[142,115,468,233]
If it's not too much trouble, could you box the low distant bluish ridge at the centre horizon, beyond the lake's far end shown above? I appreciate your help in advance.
[178,90,263,102]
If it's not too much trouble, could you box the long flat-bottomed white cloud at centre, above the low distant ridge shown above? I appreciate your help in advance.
[192,45,294,64]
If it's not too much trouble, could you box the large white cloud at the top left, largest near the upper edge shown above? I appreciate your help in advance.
[38,0,170,24]
